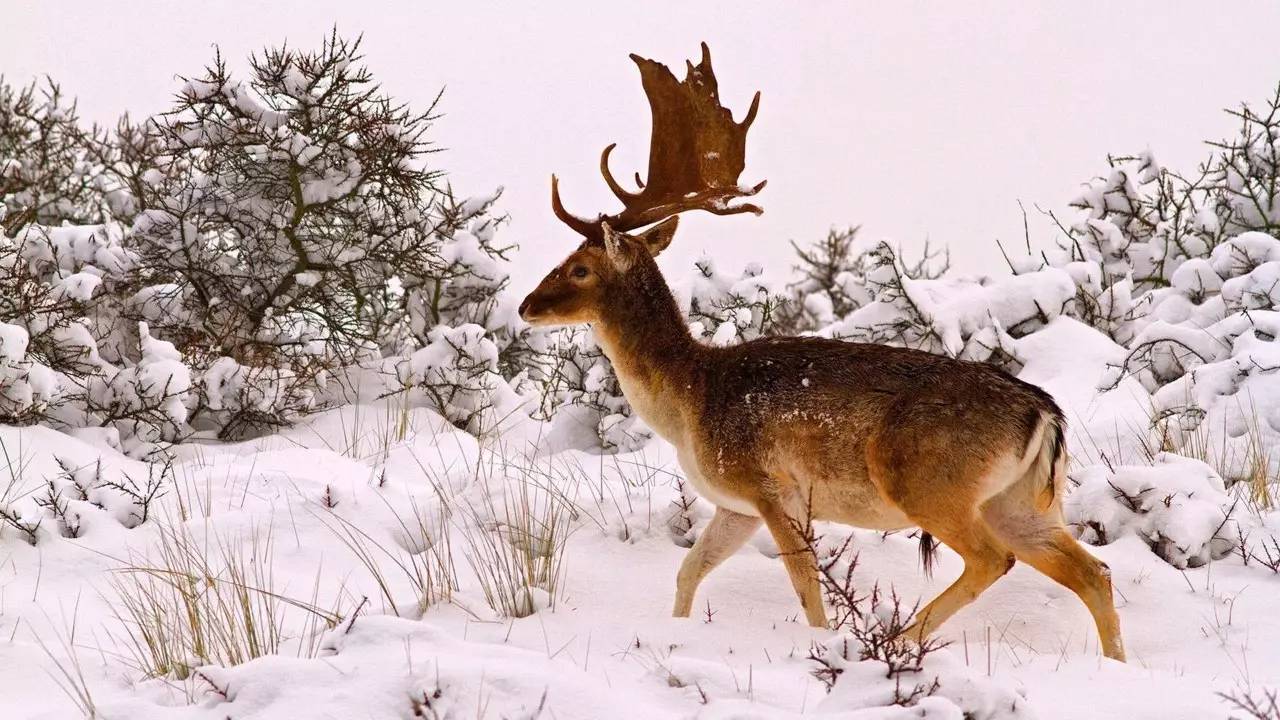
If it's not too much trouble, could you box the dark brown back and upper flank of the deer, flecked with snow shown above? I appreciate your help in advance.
[699,337,1061,460]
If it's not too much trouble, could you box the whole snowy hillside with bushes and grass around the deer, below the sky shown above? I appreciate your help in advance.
[0,33,1280,720]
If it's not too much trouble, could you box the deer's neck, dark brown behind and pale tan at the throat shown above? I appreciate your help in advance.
[594,260,704,447]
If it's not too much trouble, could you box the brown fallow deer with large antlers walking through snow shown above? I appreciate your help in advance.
[518,44,1124,661]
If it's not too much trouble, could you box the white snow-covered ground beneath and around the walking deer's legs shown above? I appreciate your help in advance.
[0,318,1280,720]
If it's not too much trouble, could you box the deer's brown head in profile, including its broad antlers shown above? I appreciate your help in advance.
[520,42,764,324]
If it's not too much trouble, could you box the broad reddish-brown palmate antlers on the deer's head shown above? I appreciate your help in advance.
[552,42,767,241]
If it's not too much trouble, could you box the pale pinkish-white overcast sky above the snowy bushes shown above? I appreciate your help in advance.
[0,0,1280,293]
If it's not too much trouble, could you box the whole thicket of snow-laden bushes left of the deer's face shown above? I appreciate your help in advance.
[0,33,527,451]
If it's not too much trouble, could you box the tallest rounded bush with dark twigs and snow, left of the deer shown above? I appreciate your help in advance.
[123,35,453,434]
